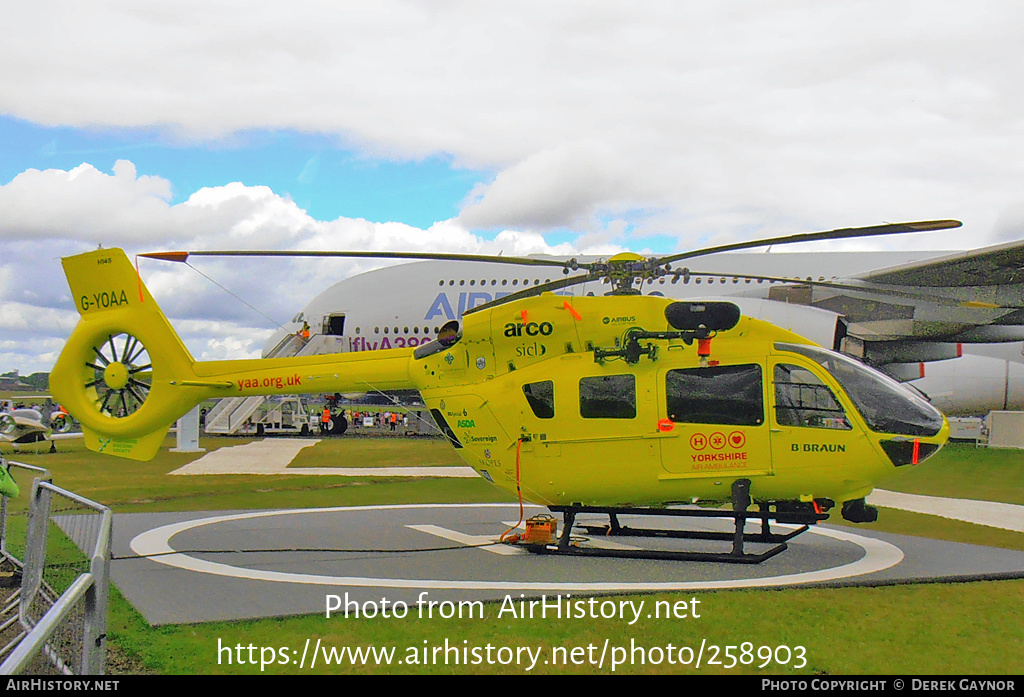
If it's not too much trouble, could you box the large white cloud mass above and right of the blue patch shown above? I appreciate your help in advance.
[0,0,1024,246]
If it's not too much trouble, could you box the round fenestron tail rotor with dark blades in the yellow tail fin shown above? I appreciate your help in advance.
[83,333,153,419]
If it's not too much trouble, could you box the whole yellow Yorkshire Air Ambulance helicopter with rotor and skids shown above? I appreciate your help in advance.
[50,221,959,563]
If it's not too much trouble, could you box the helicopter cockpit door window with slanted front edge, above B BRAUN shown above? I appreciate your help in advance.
[775,363,851,431]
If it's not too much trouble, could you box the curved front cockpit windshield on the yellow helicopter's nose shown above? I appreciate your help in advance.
[775,343,943,436]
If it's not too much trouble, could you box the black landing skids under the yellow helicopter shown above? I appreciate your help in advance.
[528,479,828,564]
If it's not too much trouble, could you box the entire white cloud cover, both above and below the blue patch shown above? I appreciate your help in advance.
[0,0,1024,369]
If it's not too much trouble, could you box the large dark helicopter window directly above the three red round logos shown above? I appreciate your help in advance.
[665,363,765,426]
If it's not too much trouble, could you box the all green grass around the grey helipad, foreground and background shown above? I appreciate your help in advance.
[6,439,1024,674]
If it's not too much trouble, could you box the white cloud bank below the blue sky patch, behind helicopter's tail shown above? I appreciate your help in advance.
[0,161,585,373]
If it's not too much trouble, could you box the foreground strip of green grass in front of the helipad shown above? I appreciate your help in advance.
[110,581,1024,676]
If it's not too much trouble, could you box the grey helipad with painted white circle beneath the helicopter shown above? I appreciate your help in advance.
[105,504,1024,624]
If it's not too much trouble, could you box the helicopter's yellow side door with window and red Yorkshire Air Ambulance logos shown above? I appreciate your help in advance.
[660,363,771,479]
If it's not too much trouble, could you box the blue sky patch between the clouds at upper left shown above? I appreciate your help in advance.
[0,117,492,228]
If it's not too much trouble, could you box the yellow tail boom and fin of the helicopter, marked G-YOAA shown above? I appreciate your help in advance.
[50,250,415,460]
